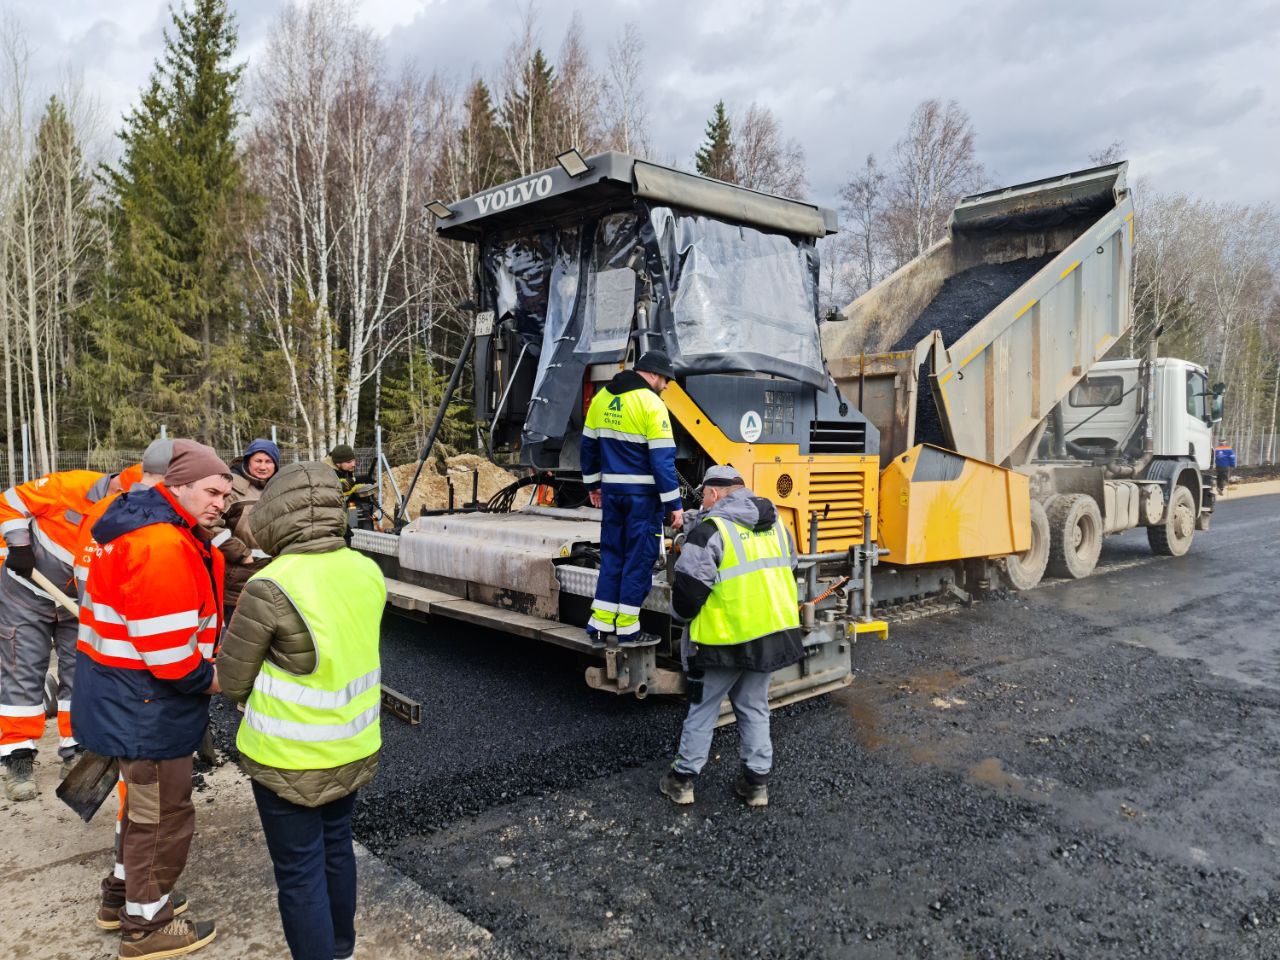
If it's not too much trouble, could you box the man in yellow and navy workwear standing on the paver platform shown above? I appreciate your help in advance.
[581,349,685,645]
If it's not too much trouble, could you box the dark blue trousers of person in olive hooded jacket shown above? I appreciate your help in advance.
[253,781,356,960]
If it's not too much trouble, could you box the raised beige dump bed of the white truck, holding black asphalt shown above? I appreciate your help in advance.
[823,163,1133,466]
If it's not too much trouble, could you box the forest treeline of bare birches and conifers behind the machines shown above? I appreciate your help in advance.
[0,0,1280,479]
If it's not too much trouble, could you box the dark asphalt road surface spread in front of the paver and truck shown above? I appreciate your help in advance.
[209,495,1280,959]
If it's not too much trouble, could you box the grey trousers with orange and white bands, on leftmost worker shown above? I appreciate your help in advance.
[0,567,79,756]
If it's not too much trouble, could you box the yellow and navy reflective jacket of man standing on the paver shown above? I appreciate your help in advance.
[581,370,680,511]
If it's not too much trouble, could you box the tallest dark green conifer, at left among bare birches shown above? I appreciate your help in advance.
[90,0,247,442]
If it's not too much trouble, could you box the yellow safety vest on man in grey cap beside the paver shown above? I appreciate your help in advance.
[689,517,800,646]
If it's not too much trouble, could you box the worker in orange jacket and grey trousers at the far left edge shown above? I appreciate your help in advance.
[0,470,110,801]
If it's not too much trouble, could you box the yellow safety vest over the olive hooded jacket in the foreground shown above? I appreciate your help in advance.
[236,548,387,771]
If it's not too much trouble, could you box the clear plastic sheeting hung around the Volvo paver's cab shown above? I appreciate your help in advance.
[480,207,827,442]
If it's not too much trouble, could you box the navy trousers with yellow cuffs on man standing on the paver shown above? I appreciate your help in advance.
[590,492,664,637]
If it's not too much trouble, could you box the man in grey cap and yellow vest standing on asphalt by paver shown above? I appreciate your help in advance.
[658,466,804,806]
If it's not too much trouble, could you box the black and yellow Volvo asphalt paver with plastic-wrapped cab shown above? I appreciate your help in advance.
[353,152,883,704]
